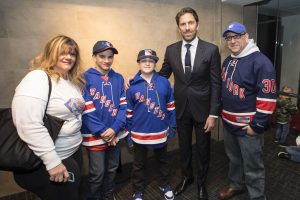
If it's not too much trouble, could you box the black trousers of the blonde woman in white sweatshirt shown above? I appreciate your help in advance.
[14,149,82,200]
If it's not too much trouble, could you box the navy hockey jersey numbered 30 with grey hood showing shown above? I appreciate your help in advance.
[222,40,277,135]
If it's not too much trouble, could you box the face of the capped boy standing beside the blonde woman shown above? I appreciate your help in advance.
[93,49,114,74]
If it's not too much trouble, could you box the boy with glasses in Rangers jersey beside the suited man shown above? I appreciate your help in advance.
[126,49,176,200]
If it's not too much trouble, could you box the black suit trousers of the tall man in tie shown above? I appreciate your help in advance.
[177,105,210,187]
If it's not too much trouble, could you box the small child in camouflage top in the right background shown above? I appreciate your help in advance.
[275,86,298,146]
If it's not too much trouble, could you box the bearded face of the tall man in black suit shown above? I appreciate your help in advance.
[178,13,198,42]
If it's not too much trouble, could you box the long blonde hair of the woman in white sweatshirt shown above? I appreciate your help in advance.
[30,35,85,88]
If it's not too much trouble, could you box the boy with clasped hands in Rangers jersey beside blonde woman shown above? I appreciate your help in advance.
[82,41,127,200]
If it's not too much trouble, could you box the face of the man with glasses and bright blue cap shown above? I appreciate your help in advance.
[225,32,249,55]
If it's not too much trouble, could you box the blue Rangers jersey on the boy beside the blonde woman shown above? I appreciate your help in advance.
[81,68,127,151]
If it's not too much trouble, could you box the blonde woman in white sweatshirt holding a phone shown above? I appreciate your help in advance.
[12,35,84,200]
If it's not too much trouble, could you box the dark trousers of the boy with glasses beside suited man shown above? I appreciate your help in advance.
[131,143,169,192]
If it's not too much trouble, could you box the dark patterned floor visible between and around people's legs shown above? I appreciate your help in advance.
[0,129,300,200]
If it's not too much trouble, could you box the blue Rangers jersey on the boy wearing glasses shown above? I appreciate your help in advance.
[126,72,176,148]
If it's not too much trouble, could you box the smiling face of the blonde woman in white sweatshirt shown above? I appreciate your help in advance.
[54,47,77,78]
